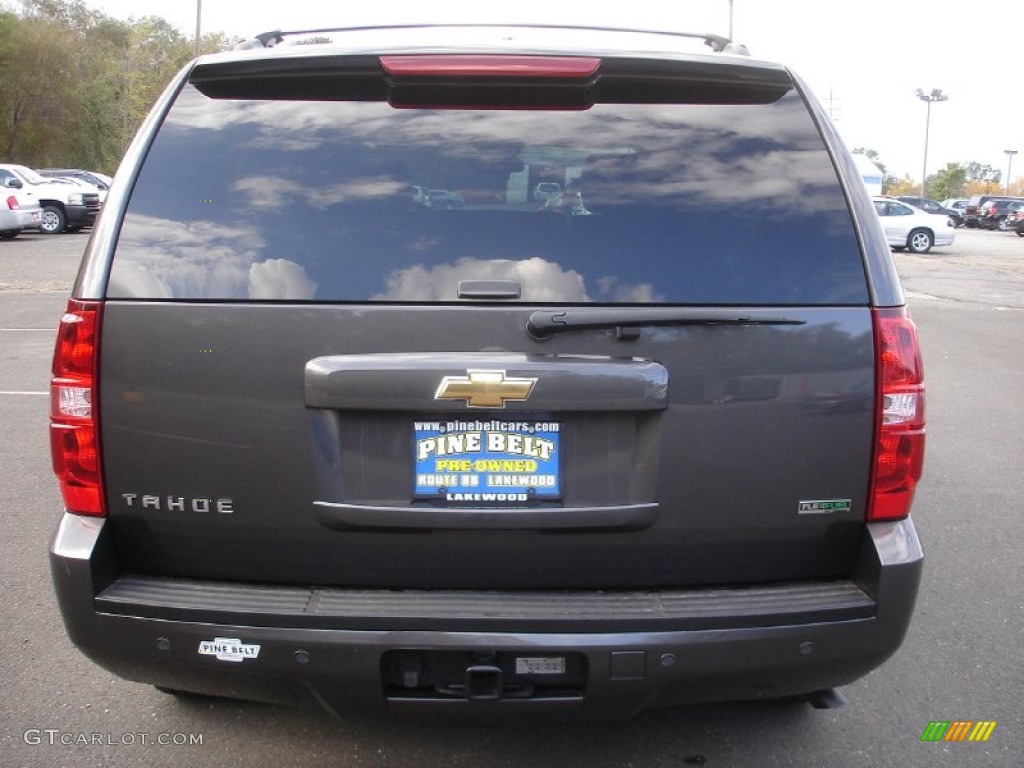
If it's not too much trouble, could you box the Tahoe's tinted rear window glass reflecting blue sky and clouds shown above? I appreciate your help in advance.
[108,79,867,304]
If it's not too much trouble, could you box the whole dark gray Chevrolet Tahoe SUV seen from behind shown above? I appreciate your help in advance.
[50,27,925,722]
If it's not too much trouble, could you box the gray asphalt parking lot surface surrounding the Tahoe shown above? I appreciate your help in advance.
[0,229,1024,768]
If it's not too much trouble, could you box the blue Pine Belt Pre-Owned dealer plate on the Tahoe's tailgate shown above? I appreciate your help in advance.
[413,420,562,506]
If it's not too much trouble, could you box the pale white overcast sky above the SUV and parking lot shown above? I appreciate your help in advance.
[75,0,1024,181]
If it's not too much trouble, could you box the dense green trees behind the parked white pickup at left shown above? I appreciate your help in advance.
[0,0,203,172]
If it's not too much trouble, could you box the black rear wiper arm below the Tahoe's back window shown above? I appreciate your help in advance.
[526,307,806,339]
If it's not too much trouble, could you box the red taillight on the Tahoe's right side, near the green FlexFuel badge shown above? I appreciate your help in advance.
[867,308,925,521]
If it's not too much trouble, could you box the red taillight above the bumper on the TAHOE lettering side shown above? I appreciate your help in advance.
[50,299,106,516]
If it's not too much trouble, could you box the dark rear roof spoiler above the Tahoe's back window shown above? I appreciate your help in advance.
[188,48,794,110]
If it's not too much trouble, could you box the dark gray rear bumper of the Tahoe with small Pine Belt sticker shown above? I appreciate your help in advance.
[50,515,923,722]
